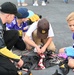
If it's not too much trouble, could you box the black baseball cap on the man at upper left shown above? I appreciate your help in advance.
[0,2,21,17]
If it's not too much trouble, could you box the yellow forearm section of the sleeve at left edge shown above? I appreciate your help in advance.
[0,47,20,60]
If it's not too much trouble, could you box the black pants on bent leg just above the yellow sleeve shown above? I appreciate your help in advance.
[4,30,26,50]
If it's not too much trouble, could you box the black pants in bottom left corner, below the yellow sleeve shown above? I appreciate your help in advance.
[0,56,18,75]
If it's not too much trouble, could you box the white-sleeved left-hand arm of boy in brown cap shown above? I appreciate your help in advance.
[23,22,40,53]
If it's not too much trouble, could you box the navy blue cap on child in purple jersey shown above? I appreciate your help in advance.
[17,7,29,19]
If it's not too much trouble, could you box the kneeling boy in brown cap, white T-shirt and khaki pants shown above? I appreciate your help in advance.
[23,18,56,54]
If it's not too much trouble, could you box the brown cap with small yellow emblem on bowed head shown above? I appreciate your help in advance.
[37,18,49,39]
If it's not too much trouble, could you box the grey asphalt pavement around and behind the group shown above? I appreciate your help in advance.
[0,0,74,75]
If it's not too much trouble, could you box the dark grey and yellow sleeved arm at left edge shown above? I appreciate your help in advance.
[0,20,20,61]
